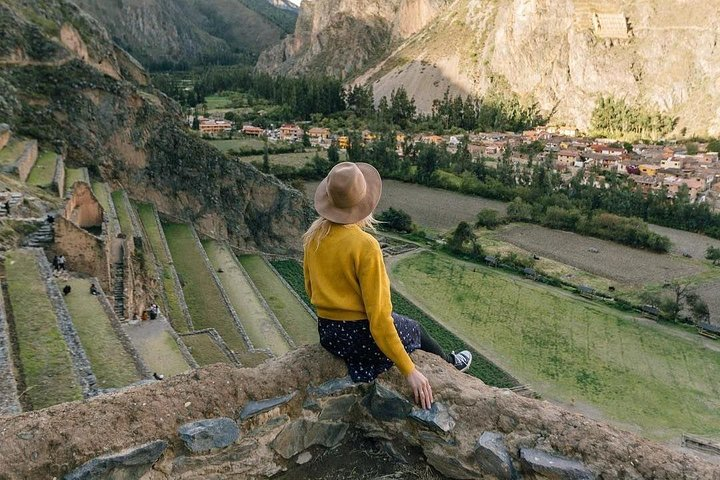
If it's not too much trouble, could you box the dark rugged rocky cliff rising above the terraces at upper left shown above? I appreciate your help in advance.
[0,0,310,251]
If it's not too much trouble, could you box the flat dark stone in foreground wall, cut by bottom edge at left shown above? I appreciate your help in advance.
[64,440,168,480]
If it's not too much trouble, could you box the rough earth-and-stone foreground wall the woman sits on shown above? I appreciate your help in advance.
[0,345,720,480]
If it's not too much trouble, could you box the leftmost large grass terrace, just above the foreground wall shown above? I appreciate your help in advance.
[5,251,82,410]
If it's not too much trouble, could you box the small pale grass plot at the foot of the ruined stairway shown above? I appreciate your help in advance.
[123,319,190,377]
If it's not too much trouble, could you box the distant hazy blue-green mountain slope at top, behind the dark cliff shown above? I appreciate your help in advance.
[76,0,297,69]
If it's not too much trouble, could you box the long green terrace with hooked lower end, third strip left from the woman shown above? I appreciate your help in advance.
[163,223,267,366]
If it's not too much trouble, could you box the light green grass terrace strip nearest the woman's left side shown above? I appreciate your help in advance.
[240,255,320,345]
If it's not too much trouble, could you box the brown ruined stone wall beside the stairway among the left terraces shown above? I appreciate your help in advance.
[55,216,111,291]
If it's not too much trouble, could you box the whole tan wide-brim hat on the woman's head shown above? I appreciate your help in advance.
[315,162,382,225]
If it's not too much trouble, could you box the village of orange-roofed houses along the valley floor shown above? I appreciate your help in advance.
[190,118,720,211]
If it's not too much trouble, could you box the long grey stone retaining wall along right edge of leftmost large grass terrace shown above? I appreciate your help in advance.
[30,248,98,398]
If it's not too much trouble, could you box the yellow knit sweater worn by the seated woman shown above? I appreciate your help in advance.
[303,224,415,375]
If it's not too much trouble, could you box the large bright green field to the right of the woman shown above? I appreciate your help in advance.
[392,253,720,440]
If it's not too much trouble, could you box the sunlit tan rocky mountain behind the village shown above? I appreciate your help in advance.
[257,0,720,135]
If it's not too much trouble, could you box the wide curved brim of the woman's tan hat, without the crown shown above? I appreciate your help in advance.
[315,162,382,225]
